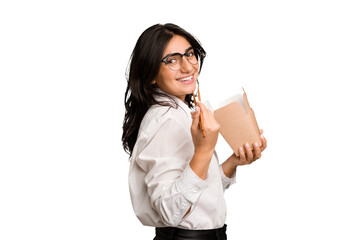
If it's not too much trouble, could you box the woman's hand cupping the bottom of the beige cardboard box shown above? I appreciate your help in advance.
[232,129,267,166]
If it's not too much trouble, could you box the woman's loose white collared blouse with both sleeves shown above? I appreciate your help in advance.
[129,94,235,229]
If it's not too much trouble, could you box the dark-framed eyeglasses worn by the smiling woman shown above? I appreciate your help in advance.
[161,47,199,71]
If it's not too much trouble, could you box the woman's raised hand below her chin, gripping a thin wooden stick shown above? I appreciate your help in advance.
[191,102,220,155]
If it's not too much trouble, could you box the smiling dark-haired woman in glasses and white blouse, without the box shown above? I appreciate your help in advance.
[122,24,266,240]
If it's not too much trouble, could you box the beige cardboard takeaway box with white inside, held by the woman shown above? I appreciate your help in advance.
[214,89,262,156]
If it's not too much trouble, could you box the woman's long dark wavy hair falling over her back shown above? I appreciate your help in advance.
[122,23,206,156]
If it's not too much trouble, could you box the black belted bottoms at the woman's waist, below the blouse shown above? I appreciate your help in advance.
[154,224,227,240]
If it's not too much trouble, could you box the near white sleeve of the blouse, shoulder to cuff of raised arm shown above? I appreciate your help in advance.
[136,118,207,226]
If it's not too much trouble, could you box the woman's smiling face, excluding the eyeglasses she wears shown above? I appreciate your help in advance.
[153,35,199,102]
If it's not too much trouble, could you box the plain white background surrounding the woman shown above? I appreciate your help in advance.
[0,0,360,240]
